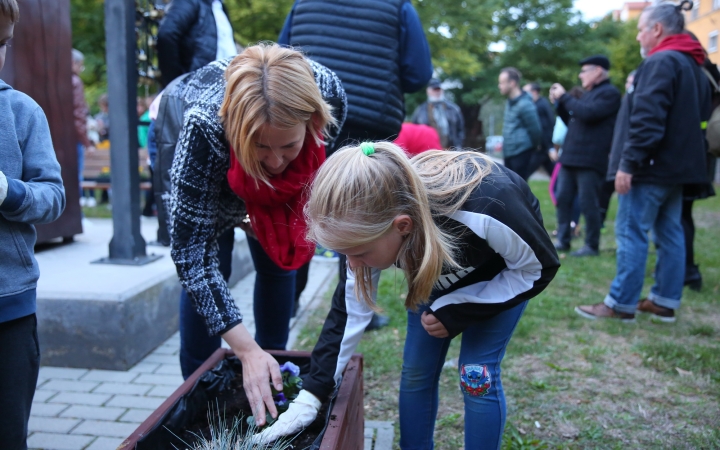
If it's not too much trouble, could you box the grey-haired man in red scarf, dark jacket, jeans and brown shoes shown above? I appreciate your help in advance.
[575,0,712,322]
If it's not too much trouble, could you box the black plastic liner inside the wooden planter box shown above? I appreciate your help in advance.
[135,356,337,450]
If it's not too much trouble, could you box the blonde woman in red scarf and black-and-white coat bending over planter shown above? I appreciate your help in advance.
[170,44,347,425]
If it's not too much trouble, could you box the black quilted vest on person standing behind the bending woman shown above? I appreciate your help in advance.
[290,0,408,137]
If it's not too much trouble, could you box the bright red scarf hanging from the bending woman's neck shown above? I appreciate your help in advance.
[228,133,325,270]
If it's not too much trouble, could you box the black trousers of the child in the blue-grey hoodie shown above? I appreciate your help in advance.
[0,314,40,450]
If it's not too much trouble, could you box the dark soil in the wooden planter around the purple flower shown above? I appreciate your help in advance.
[178,358,330,450]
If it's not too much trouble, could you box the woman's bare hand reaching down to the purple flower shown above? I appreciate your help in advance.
[223,324,283,427]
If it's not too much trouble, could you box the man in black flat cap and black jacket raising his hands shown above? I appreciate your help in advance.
[550,55,621,256]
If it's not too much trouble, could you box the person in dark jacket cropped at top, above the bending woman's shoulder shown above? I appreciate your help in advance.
[157,0,237,86]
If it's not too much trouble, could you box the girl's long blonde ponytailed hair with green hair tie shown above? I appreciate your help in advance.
[305,142,494,310]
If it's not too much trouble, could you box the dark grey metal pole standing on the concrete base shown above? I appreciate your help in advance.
[96,0,160,265]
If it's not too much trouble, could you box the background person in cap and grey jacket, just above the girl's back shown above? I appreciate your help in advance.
[410,78,465,148]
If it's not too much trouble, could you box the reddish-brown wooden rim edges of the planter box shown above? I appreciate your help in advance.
[117,348,365,450]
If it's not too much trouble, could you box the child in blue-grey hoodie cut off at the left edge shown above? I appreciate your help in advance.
[0,0,65,450]
